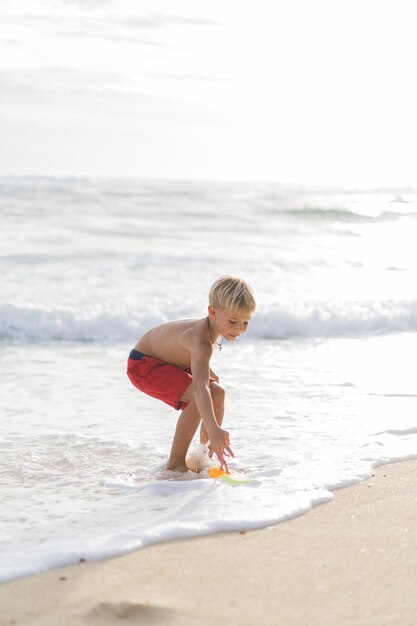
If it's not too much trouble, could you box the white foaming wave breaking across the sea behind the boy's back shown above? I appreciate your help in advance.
[0,300,417,344]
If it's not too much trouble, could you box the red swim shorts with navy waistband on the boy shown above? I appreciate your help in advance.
[127,350,193,410]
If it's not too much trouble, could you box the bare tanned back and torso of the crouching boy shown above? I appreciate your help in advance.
[135,317,211,369]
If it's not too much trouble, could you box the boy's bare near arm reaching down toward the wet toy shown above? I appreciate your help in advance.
[191,340,234,470]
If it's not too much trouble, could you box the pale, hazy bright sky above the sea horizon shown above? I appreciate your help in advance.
[0,0,417,187]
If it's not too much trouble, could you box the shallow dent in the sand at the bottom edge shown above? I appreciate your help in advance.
[85,602,173,626]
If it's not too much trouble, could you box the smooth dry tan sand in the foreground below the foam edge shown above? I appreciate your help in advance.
[0,461,417,626]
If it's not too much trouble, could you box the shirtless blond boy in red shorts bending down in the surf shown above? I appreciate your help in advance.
[127,276,256,472]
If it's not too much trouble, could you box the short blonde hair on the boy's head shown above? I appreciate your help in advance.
[209,274,256,314]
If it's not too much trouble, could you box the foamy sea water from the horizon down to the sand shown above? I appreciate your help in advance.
[0,178,417,580]
